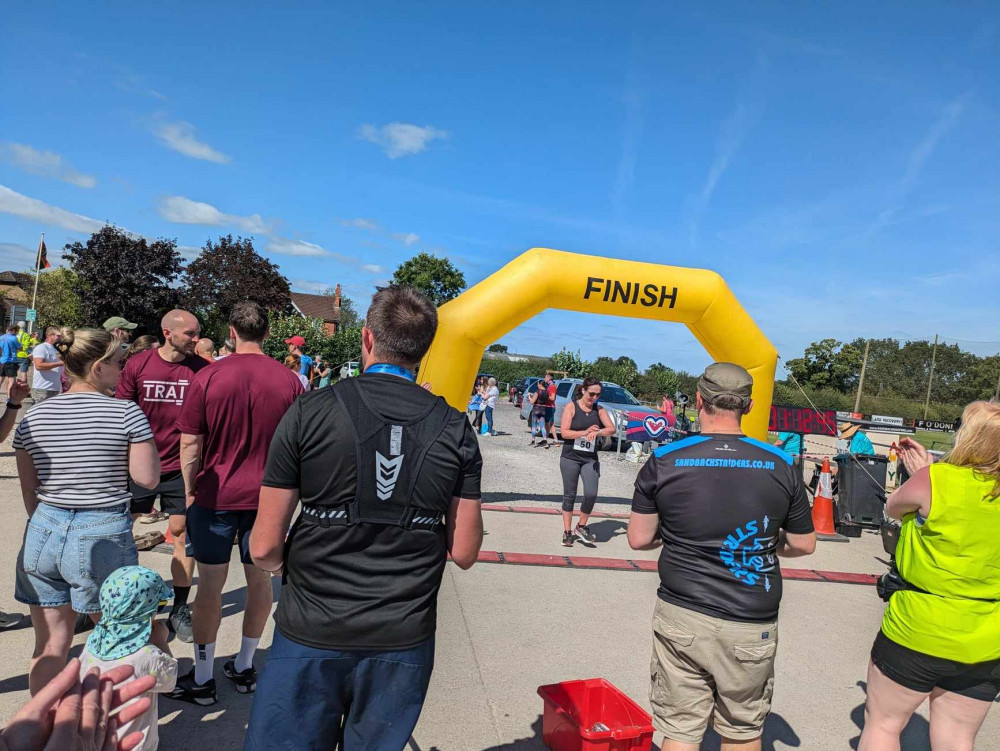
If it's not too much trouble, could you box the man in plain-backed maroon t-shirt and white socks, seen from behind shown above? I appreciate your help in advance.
[167,302,303,706]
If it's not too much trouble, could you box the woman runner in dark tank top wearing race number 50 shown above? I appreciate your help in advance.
[559,378,615,548]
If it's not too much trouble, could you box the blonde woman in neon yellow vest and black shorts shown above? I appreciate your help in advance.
[858,402,1000,751]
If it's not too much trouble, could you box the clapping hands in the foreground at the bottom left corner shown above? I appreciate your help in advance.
[0,659,156,751]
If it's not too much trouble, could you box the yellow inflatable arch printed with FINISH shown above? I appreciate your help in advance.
[420,248,778,440]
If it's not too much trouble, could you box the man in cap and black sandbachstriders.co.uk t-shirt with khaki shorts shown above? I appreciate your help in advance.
[628,363,816,751]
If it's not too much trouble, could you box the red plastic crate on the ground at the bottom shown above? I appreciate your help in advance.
[538,678,653,751]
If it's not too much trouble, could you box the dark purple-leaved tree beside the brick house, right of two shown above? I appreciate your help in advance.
[182,235,291,339]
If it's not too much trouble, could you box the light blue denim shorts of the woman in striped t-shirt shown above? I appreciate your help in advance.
[14,503,139,613]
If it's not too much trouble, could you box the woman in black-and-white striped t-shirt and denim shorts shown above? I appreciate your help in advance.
[14,329,160,695]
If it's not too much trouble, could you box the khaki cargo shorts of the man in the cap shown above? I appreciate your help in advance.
[649,600,778,743]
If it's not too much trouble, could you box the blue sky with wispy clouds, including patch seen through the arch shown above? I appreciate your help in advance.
[0,2,1000,370]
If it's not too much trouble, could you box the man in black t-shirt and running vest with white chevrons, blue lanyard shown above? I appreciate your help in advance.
[245,287,483,751]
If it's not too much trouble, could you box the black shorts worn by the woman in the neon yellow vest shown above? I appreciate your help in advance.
[872,631,1000,701]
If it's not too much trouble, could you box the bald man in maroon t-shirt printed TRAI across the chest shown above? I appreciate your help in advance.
[115,310,208,642]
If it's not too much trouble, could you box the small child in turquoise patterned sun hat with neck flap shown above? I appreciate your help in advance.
[80,566,177,751]
